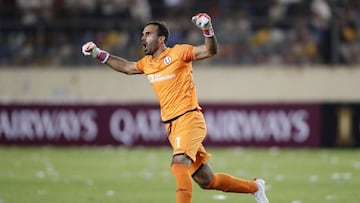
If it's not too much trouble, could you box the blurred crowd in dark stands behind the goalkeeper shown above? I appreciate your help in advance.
[0,0,360,67]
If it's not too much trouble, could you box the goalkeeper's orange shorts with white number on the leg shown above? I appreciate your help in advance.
[165,110,211,174]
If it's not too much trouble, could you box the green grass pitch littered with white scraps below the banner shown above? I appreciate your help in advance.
[0,146,360,203]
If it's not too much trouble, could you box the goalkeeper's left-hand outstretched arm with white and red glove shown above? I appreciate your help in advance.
[82,42,141,75]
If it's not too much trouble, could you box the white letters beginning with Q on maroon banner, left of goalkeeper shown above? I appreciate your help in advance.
[109,109,166,146]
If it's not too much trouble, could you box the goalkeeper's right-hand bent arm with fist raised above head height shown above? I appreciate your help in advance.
[192,13,218,60]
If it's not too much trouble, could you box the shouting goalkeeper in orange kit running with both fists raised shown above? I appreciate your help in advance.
[82,13,269,203]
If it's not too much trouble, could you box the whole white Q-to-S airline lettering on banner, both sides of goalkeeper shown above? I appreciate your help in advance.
[109,108,310,146]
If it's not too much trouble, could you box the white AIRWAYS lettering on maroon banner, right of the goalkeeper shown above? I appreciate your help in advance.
[204,110,310,143]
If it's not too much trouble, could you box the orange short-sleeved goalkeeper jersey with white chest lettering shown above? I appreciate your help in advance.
[136,44,200,121]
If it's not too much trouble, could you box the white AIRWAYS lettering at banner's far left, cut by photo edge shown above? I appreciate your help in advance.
[0,109,98,141]
